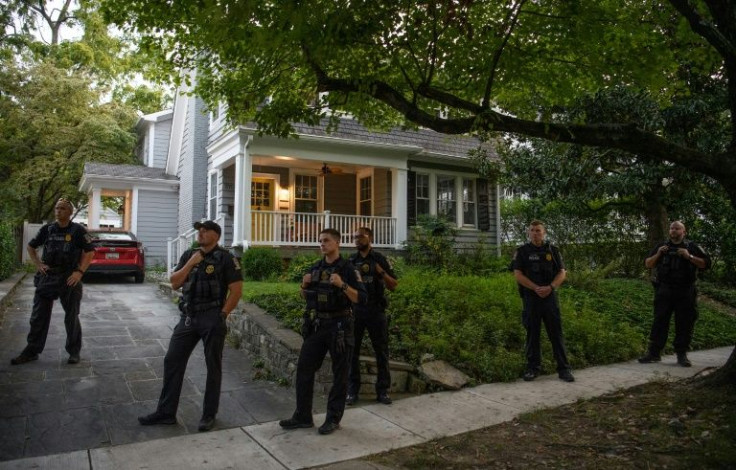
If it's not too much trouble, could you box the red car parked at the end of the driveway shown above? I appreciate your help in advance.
[87,229,146,283]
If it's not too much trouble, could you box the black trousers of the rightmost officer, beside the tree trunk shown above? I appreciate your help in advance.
[649,284,698,354]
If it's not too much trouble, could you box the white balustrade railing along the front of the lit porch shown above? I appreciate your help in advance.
[250,211,397,248]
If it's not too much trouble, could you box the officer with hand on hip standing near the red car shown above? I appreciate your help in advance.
[10,198,94,365]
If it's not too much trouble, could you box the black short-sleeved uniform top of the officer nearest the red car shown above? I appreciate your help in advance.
[28,222,94,271]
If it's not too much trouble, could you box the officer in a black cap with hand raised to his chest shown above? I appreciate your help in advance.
[138,220,243,431]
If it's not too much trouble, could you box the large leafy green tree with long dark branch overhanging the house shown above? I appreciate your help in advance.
[103,0,736,377]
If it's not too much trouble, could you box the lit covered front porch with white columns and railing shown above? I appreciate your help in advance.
[168,129,418,274]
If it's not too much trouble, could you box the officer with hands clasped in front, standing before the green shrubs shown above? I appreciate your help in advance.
[513,220,575,382]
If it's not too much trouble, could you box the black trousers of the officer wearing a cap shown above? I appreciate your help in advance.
[158,307,227,417]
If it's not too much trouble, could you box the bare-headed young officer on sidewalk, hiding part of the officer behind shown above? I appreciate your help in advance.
[279,228,367,434]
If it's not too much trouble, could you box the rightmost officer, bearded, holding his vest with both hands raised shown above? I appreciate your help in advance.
[639,220,711,367]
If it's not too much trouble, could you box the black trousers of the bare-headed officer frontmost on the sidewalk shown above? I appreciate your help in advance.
[294,317,355,423]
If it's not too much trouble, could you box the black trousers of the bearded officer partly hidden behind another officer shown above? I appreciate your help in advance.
[348,310,391,396]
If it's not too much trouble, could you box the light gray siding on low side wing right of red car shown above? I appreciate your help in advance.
[136,190,177,266]
